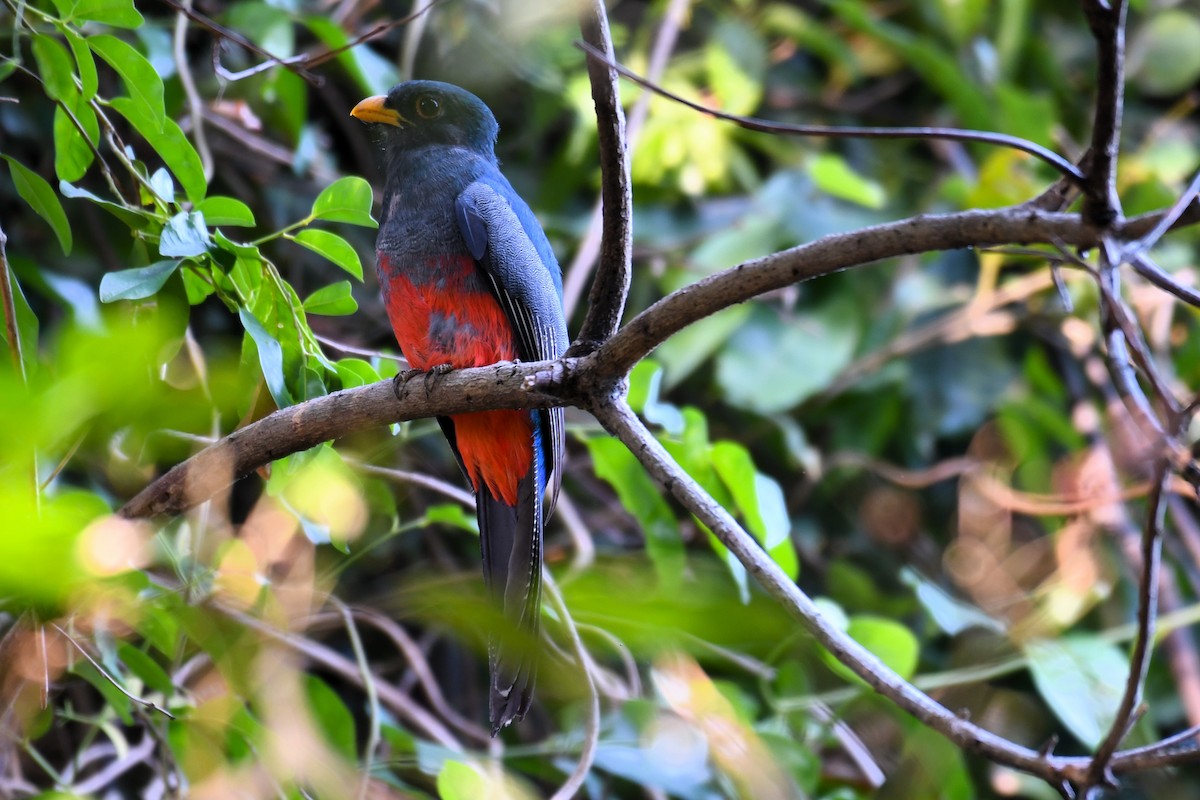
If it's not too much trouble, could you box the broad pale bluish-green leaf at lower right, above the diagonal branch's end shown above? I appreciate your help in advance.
[1022,636,1129,750]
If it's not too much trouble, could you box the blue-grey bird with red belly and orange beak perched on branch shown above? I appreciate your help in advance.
[350,80,568,736]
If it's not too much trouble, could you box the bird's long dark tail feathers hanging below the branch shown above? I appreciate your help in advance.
[476,450,546,736]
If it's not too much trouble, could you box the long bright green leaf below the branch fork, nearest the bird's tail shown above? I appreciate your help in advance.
[588,437,684,584]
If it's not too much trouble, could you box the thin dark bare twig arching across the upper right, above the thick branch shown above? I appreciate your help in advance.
[576,42,1085,182]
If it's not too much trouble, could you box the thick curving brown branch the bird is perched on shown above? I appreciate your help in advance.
[121,207,1200,517]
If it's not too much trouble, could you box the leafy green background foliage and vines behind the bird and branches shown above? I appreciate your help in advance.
[0,0,1200,800]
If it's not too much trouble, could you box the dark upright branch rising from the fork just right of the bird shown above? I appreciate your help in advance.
[571,0,634,355]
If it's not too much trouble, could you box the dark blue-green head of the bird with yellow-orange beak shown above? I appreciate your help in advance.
[350,80,499,156]
